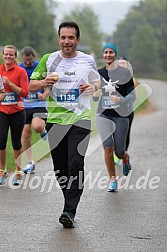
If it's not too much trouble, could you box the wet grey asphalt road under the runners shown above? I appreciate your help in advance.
[0,80,167,252]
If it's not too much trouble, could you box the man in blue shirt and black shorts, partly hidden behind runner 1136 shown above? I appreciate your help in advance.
[19,47,48,173]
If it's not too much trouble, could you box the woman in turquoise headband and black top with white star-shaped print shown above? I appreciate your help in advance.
[93,43,135,192]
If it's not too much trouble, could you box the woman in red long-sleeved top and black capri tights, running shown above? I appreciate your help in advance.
[0,45,28,185]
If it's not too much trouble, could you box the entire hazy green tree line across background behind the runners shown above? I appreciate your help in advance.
[0,0,167,76]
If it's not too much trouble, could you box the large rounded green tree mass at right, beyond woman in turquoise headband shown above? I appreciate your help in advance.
[113,0,167,76]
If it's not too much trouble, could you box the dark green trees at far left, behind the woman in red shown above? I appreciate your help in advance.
[0,0,57,54]
